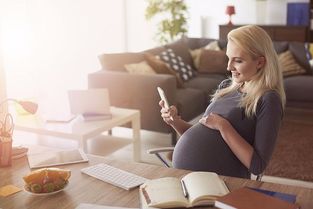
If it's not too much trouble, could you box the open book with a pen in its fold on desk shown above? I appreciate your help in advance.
[139,172,229,208]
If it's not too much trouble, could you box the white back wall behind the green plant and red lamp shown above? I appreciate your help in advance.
[127,0,309,51]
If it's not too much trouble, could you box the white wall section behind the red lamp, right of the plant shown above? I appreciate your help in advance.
[186,0,309,38]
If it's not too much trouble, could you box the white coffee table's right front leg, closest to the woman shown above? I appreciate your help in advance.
[132,112,141,162]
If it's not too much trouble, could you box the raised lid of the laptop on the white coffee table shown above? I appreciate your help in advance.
[68,89,111,115]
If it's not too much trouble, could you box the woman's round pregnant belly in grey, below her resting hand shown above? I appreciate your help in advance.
[173,123,246,176]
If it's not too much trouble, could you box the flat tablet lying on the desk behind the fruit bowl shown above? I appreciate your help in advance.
[27,149,88,168]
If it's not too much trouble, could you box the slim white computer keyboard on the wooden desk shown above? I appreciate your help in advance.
[81,163,147,190]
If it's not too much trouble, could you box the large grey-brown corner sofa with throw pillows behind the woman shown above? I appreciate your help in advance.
[88,37,313,144]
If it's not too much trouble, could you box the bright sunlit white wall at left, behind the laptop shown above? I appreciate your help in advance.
[0,0,126,114]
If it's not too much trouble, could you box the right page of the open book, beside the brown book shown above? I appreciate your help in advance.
[183,172,229,206]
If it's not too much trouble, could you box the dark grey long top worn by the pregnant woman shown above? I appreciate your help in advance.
[173,85,283,178]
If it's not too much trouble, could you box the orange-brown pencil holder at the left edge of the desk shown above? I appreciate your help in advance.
[0,135,12,167]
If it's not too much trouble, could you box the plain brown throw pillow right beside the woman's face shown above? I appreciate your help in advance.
[198,49,228,74]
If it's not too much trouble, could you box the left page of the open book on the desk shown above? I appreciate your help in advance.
[142,177,189,208]
